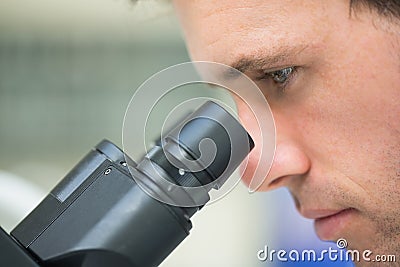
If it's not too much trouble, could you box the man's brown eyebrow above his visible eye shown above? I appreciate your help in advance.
[224,45,308,79]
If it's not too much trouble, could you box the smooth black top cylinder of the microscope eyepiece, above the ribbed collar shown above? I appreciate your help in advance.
[165,101,254,184]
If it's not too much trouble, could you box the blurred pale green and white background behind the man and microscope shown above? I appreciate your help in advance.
[0,0,351,267]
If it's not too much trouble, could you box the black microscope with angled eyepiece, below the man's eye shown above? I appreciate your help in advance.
[0,101,254,267]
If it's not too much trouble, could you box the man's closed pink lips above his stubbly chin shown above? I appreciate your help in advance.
[302,208,356,240]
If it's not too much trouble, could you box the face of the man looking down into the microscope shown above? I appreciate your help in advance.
[174,0,400,253]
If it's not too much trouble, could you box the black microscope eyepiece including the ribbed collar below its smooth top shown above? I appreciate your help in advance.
[134,101,254,207]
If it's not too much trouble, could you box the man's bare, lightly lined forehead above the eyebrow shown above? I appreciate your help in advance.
[174,0,349,64]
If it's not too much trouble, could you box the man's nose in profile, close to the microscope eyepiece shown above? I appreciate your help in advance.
[238,98,311,191]
